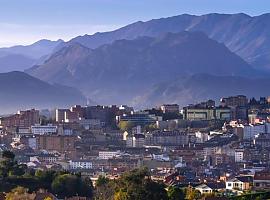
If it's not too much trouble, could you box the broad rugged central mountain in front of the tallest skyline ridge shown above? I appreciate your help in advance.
[27,31,266,106]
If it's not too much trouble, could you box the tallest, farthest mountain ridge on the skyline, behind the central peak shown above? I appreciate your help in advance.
[62,13,270,70]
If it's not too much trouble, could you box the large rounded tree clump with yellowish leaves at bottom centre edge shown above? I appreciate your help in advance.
[95,169,168,200]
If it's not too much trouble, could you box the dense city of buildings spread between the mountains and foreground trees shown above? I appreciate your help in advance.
[0,95,270,195]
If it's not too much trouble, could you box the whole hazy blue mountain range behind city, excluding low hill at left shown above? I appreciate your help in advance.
[0,13,270,111]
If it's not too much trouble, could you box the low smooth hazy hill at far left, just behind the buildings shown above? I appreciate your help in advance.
[0,72,86,114]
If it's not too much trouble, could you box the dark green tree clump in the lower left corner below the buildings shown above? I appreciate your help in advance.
[0,151,93,198]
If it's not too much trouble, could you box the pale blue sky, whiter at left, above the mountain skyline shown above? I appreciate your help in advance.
[0,0,270,47]
